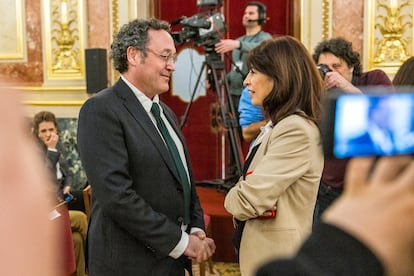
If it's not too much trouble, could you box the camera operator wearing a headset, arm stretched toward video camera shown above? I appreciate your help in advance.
[215,2,272,118]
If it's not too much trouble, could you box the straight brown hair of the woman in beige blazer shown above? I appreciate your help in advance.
[247,36,325,124]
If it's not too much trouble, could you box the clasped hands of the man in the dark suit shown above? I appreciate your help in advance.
[184,231,216,263]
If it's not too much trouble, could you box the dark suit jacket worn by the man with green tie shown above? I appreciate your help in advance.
[78,79,204,276]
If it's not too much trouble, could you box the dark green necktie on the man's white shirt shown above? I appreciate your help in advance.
[151,103,191,225]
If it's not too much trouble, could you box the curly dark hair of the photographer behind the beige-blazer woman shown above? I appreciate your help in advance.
[312,37,362,77]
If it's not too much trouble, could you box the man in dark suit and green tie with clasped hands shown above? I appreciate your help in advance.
[78,19,215,276]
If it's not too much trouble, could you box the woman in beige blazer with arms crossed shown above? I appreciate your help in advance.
[224,36,324,276]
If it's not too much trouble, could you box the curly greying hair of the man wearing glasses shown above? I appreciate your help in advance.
[110,18,170,73]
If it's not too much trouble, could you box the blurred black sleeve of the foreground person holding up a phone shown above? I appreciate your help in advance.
[256,224,384,276]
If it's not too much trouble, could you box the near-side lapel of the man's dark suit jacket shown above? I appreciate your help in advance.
[114,79,181,180]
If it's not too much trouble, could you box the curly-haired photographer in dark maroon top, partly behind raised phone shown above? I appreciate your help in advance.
[312,38,393,220]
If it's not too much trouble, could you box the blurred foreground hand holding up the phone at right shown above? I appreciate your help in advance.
[322,156,414,275]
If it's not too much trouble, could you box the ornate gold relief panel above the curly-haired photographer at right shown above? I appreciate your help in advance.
[364,0,414,75]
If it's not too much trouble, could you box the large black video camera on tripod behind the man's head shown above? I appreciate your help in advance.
[172,0,226,48]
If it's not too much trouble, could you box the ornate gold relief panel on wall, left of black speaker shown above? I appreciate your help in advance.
[42,0,86,83]
